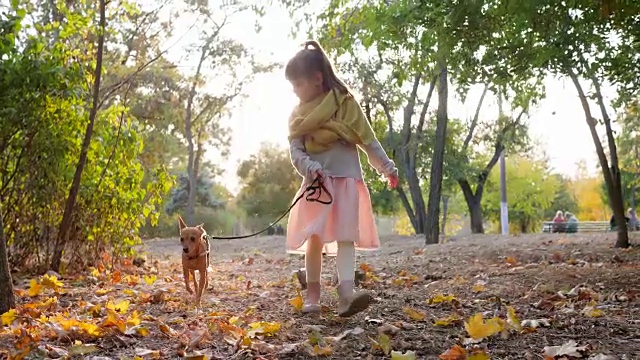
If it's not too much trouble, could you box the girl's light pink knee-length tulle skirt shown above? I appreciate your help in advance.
[286,177,380,255]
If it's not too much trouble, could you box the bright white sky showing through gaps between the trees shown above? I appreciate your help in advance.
[160,2,613,193]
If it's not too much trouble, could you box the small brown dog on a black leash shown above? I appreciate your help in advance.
[178,216,209,305]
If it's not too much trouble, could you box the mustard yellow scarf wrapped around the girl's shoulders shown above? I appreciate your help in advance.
[289,90,376,153]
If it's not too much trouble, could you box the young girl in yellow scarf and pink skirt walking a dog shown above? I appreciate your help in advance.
[285,41,398,317]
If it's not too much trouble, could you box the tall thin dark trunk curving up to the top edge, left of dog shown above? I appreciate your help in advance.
[49,0,106,272]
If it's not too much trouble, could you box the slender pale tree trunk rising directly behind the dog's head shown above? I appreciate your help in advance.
[184,42,209,226]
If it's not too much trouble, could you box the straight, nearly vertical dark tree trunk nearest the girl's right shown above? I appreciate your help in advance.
[425,59,448,244]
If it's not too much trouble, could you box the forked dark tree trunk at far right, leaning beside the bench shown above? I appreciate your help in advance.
[568,69,629,248]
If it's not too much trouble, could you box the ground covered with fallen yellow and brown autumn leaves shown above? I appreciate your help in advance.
[0,234,640,360]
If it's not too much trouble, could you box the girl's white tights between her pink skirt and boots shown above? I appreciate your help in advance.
[304,236,356,283]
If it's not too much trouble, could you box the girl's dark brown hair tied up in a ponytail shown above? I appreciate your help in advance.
[284,40,351,94]
